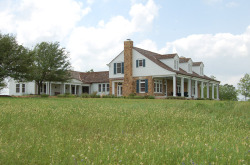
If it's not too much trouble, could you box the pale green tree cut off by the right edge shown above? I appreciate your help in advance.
[238,73,250,101]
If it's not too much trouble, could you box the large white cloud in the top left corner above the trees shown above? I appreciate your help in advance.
[0,0,91,46]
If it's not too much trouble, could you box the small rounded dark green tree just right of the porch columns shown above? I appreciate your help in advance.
[219,84,238,101]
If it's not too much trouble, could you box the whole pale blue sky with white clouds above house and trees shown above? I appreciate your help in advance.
[0,0,250,92]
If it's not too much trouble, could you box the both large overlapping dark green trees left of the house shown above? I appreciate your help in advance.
[0,33,71,95]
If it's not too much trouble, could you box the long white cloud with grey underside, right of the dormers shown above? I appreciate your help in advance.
[161,26,250,85]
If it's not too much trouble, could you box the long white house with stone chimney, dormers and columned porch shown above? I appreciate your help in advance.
[10,40,220,99]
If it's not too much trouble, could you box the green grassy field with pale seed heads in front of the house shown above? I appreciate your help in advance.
[0,98,250,165]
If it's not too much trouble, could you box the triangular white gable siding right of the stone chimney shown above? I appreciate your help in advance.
[132,50,175,77]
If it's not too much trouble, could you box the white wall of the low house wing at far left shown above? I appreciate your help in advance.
[9,79,35,96]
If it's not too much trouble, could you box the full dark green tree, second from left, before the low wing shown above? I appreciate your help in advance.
[31,42,71,95]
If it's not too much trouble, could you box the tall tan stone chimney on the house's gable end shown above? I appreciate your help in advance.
[123,39,133,96]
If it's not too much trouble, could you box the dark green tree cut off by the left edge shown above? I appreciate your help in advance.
[0,33,33,89]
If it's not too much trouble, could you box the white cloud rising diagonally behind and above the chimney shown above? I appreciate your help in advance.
[66,0,158,71]
